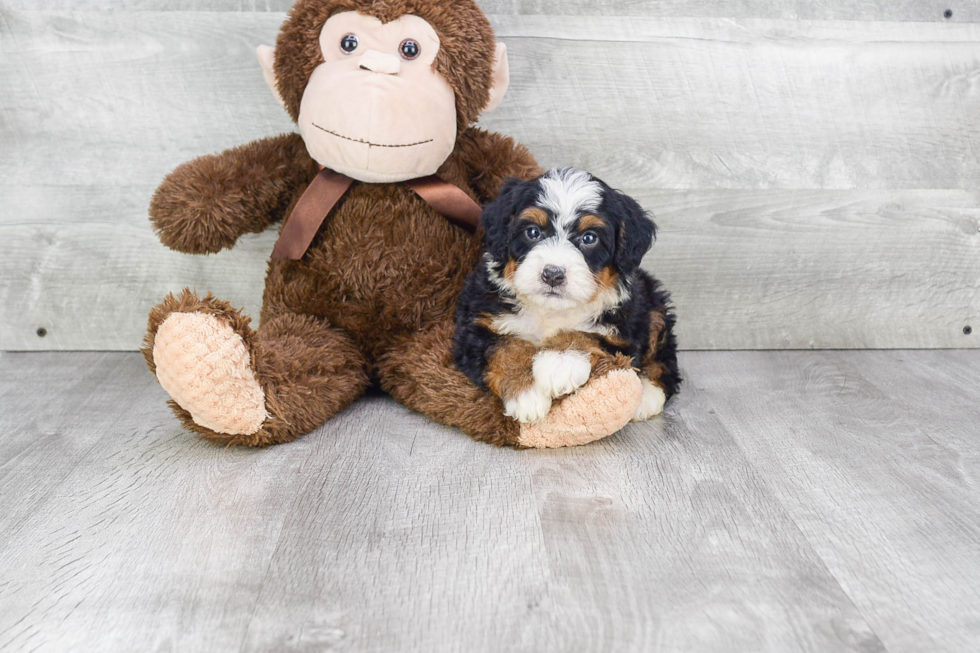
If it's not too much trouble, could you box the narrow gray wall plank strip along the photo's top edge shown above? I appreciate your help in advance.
[0,0,980,22]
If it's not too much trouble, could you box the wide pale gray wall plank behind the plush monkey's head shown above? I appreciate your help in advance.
[0,11,980,189]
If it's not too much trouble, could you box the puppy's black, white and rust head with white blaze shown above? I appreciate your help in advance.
[483,168,656,310]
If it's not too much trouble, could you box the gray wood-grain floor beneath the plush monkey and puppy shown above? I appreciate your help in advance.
[0,351,980,652]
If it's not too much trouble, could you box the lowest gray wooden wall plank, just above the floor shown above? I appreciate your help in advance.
[0,186,980,350]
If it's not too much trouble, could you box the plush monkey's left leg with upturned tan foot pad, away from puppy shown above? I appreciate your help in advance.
[143,290,369,447]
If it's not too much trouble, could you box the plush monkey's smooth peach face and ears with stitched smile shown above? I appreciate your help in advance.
[259,3,507,182]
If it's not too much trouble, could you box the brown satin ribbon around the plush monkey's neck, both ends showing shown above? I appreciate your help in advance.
[272,168,483,261]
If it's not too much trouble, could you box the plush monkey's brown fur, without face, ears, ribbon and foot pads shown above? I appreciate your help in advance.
[143,0,542,446]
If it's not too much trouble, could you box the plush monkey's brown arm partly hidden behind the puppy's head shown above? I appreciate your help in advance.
[458,127,544,203]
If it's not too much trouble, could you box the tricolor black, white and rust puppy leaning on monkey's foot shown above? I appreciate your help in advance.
[455,168,681,422]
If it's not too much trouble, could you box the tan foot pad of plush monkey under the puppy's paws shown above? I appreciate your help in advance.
[518,370,643,449]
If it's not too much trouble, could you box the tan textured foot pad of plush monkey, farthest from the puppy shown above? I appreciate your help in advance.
[153,313,268,435]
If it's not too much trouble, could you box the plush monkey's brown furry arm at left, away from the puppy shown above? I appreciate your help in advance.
[150,134,316,254]
